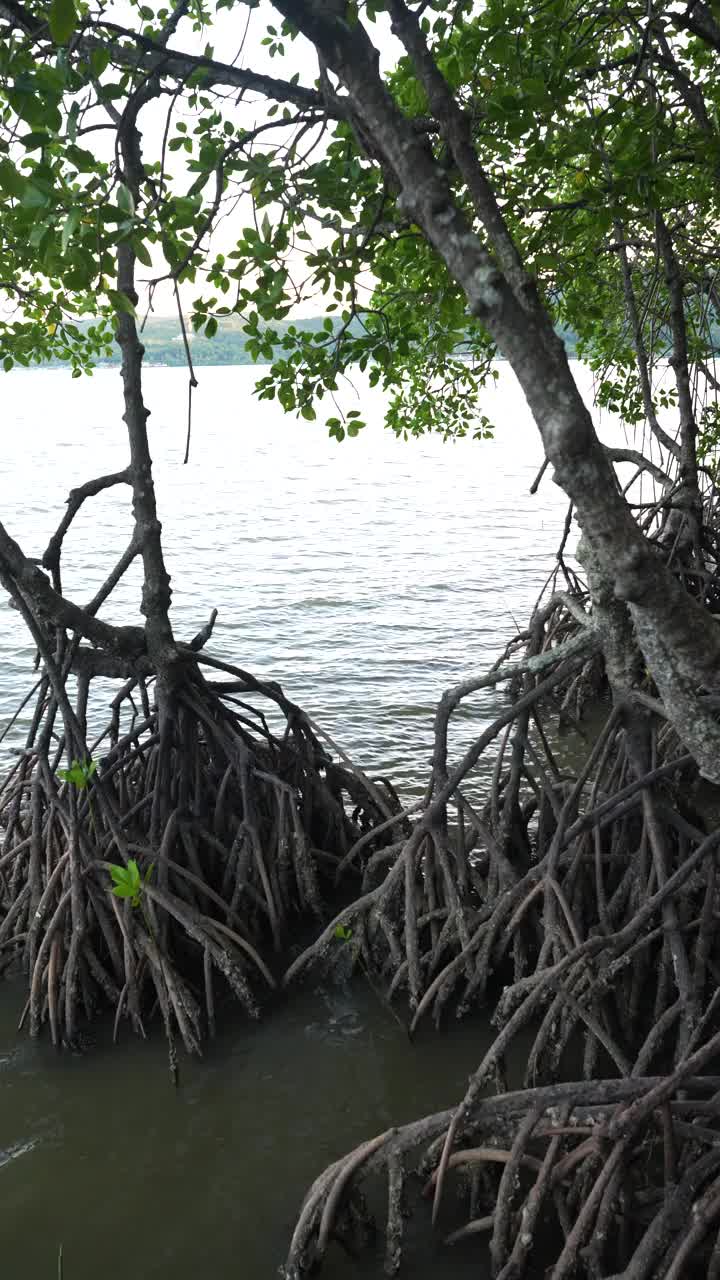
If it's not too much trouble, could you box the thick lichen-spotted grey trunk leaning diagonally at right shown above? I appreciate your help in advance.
[275,0,720,782]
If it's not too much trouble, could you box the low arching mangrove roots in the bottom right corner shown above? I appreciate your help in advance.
[283,1075,720,1280]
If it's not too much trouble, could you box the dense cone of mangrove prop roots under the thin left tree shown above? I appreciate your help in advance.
[0,654,397,1052]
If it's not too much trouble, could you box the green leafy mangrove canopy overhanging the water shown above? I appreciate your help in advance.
[0,0,720,452]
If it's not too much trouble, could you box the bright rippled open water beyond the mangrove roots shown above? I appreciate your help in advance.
[0,366,566,788]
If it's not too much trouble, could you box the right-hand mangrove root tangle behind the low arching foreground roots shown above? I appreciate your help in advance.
[286,586,720,1084]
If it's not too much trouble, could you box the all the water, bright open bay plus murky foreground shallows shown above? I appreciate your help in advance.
[0,369,617,1280]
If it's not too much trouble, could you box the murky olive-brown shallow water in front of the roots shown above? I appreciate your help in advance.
[0,967,538,1280]
